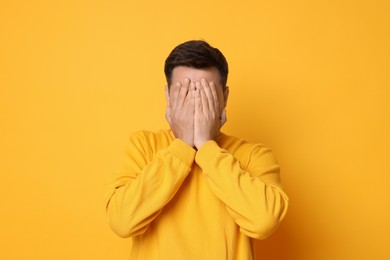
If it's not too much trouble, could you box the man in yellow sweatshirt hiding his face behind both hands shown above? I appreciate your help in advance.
[106,41,288,260]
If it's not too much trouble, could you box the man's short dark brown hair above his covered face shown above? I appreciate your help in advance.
[164,40,229,88]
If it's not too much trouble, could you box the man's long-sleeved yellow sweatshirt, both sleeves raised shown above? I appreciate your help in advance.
[106,130,288,260]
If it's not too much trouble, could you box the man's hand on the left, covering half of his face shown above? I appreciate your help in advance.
[166,78,195,147]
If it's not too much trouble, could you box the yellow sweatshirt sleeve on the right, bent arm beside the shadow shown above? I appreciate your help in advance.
[195,141,288,239]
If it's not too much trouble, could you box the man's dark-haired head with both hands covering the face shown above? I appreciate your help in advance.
[164,41,229,144]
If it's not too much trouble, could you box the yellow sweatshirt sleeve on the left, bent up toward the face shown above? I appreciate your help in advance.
[106,132,195,237]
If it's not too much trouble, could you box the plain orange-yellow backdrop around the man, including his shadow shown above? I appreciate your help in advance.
[0,0,390,260]
